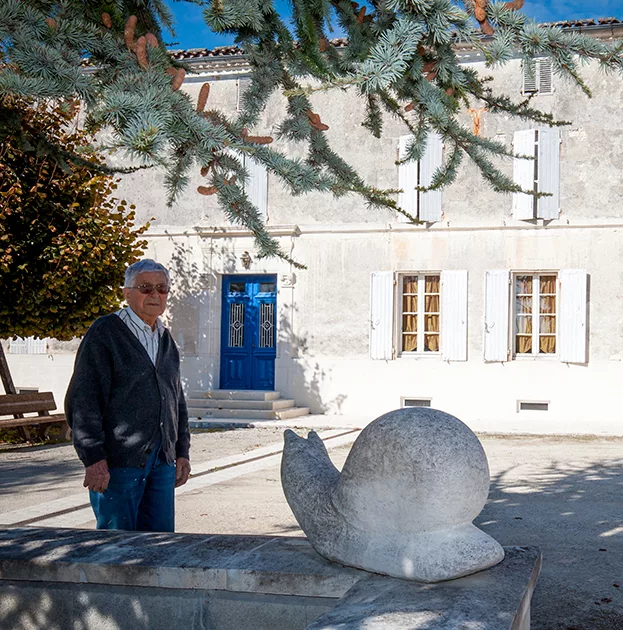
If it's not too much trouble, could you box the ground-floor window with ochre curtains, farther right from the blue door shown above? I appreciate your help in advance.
[514,273,558,356]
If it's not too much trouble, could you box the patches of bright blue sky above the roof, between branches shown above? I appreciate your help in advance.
[165,0,623,48]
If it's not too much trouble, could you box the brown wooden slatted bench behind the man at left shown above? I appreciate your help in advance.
[0,392,71,440]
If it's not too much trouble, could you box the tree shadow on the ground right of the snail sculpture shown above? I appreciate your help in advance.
[475,459,623,630]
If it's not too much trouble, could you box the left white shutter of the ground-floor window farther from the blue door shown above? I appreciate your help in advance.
[485,269,510,361]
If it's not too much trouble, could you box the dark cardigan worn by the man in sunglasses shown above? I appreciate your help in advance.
[65,314,190,468]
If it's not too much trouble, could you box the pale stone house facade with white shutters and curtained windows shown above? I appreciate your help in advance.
[8,20,623,435]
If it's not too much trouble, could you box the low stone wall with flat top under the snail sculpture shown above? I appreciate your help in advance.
[0,528,540,630]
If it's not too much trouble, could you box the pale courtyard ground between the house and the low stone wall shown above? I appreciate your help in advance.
[0,428,623,630]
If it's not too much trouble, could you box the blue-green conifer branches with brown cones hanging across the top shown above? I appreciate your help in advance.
[0,0,623,262]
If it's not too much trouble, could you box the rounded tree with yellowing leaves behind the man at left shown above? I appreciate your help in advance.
[0,96,147,340]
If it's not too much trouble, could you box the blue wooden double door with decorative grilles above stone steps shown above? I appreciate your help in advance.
[220,275,277,390]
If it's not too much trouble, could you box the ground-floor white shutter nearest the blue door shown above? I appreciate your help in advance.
[370,271,394,360]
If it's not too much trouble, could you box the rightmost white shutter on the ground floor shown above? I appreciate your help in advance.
[558,269,588,363]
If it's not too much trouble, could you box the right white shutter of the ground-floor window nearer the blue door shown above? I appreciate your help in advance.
[441,270,467,361]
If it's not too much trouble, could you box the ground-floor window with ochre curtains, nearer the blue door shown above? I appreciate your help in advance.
[400,274,441,354]
